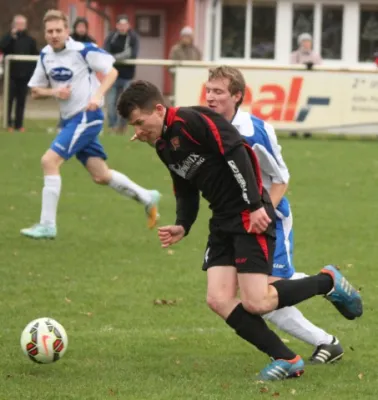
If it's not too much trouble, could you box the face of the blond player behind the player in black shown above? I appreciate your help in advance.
[206,78,241,120]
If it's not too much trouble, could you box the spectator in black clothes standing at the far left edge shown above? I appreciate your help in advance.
[0,15,38,131]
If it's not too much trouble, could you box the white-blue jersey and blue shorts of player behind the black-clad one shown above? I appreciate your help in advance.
[232,110,295,279]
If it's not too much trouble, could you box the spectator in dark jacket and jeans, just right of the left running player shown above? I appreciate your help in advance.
[104,15,139,133]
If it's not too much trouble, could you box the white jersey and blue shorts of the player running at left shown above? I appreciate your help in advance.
[28,38,114,164]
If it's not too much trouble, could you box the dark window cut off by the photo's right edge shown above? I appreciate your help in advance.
[358,5,378,61]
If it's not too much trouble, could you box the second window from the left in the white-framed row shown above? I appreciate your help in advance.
[250,0,276,59]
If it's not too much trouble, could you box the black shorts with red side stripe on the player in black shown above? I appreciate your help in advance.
[202,211,275,275]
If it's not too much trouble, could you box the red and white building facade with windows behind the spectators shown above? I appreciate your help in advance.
[57,0,378,92]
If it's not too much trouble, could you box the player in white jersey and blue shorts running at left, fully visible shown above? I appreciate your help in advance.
[21,10,160,239]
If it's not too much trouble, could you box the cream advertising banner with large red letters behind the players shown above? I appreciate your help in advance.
[175,67,378,135]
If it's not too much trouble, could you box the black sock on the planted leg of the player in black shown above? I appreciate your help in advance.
[226,304,296,360]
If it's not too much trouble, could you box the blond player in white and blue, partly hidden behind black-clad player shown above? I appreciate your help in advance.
[206,66,343,363]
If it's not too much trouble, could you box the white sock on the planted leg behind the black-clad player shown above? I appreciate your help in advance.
[263,307,333,347]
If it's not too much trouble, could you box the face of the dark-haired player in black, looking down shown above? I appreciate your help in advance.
[129,104,166,146]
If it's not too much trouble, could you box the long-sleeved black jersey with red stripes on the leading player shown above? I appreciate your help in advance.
[156,107,270,233]
